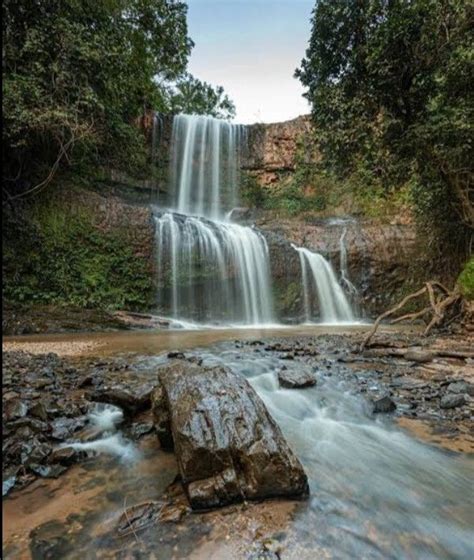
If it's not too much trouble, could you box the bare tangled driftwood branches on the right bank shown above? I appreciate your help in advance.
[360,282,462,350]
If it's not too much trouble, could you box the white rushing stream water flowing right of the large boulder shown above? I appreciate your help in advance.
[200,349,474,560]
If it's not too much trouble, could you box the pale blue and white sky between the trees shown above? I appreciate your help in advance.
[188,0,315,124]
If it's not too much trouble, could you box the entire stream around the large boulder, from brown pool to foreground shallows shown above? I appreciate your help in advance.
[4,328,474,560]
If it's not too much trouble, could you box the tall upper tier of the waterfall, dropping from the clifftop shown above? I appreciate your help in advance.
[170,115,245,219]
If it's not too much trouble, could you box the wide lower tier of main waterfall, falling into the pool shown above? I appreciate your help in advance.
[156,212,272,324]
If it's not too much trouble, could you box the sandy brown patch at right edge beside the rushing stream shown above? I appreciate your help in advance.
[397,418,474,453]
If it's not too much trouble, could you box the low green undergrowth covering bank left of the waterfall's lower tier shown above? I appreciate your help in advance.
[3,197,153,309]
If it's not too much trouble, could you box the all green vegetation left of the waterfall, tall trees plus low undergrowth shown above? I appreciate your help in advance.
[2,0,235,309]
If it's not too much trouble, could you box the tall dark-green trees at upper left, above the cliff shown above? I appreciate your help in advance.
[3,0,233,192]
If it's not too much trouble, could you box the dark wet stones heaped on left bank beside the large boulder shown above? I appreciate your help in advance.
[2,351,161,495]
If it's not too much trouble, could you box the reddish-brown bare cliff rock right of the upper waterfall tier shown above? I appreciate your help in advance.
[242,115,317,187]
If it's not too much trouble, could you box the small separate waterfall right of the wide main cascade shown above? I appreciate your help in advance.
[292,245,354,323]
